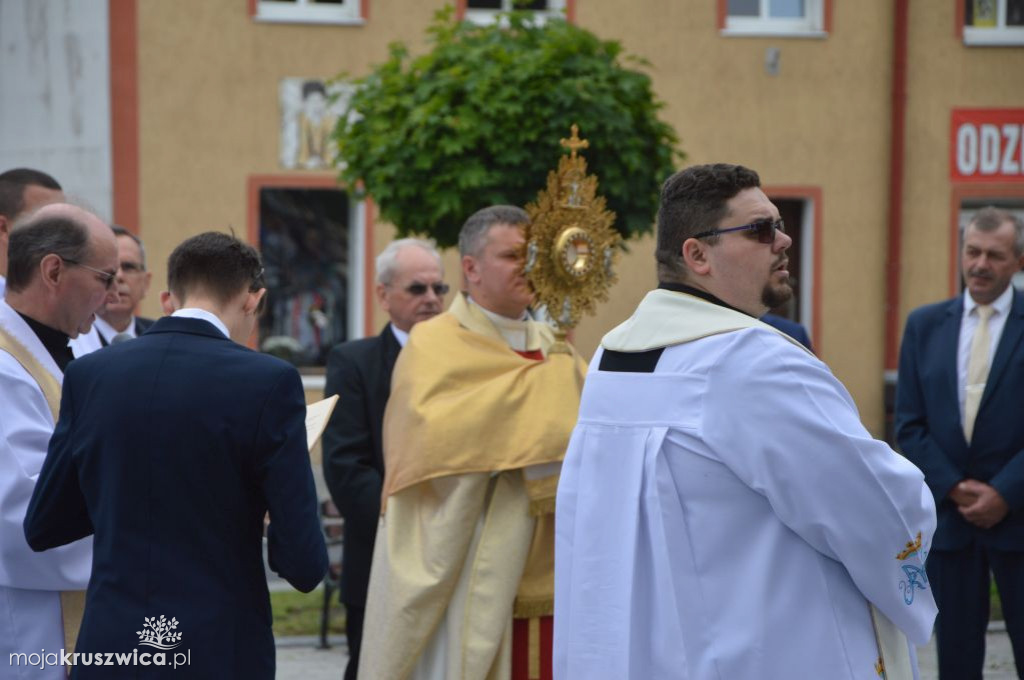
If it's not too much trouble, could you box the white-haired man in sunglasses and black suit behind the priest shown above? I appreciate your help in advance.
[324,239,449,680]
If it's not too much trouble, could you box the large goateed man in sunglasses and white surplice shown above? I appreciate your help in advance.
[554,164,936,680]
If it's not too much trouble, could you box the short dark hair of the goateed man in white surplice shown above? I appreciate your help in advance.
[654,163,761,282]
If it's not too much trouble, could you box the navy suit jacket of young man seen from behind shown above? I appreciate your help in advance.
[25,316,327,680]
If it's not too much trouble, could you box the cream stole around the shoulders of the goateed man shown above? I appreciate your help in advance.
[601,289,913,680]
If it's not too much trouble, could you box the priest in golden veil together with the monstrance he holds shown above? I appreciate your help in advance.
[359,131,617,680]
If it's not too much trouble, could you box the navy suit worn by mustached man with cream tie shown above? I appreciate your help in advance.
[895,292,1024,680]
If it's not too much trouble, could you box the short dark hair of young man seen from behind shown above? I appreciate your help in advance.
[167,231,264,304]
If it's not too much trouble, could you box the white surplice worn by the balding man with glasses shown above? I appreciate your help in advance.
[0,300,92,680]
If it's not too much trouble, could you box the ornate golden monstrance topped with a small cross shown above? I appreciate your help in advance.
[523,124,622,352]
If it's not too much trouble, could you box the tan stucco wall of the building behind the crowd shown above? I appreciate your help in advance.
[132,0,1024,434]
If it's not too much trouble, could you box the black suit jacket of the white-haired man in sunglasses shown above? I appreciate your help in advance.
[323,324,401,606]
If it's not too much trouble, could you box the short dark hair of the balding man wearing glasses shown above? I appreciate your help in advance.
[7,210,90,293]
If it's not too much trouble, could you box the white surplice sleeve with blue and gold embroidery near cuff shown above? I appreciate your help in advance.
[700,330,936,644]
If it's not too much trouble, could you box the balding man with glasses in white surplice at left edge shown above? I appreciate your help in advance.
[0,204,118,678]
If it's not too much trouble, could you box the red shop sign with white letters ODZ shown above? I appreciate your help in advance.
[949,109,1024,182]
